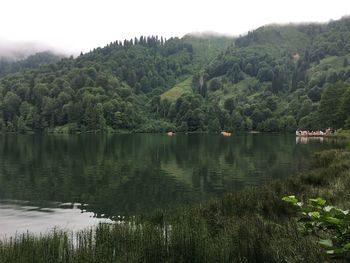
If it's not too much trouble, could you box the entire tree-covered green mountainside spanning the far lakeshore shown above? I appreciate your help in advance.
[0,18,350,132]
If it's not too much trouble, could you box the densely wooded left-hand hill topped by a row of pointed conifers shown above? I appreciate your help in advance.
[0,37,198,132]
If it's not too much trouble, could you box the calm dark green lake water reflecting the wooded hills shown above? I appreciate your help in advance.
[0,134,342,236]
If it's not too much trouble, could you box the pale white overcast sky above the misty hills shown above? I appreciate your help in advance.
[0,0,350,54]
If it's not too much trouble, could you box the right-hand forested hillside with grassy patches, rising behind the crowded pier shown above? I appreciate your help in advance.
[189,18,350,131]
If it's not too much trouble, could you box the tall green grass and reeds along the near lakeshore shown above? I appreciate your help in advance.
[0,150,350,263]
